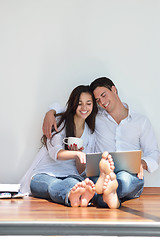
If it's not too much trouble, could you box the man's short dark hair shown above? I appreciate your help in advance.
[90,77,115,91]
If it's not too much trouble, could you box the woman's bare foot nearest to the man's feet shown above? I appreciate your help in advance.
[80,178,95,207]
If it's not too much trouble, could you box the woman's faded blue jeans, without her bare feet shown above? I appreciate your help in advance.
[30,173,84,206]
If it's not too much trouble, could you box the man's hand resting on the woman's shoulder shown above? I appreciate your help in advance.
[42,110,58,138]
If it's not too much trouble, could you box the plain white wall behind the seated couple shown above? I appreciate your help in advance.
[0,0,160,186]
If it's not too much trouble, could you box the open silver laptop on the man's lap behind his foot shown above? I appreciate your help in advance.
[86,150,142,177]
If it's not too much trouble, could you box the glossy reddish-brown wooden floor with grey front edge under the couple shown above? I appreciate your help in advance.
[0,188,160,236]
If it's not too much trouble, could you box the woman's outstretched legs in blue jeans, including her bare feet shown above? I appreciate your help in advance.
[30,174,95,207]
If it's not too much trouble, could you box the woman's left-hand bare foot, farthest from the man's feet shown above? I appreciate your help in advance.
[68,181,86,207]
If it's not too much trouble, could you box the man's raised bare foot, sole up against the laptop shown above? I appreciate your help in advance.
[95,152,115,194]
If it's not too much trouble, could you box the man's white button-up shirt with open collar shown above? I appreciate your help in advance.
[49,103,160,172]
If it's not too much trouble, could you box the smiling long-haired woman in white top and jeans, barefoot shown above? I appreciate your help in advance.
[21,85,97,206]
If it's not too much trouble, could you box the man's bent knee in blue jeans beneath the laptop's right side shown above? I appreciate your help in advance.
[116,171,144,201]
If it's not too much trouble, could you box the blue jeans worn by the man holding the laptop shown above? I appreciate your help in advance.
[90,171,144,207]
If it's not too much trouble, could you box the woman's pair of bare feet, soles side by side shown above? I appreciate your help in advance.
[68,178,95,207]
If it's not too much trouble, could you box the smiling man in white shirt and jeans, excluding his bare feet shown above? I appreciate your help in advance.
[43,77,160,204]
